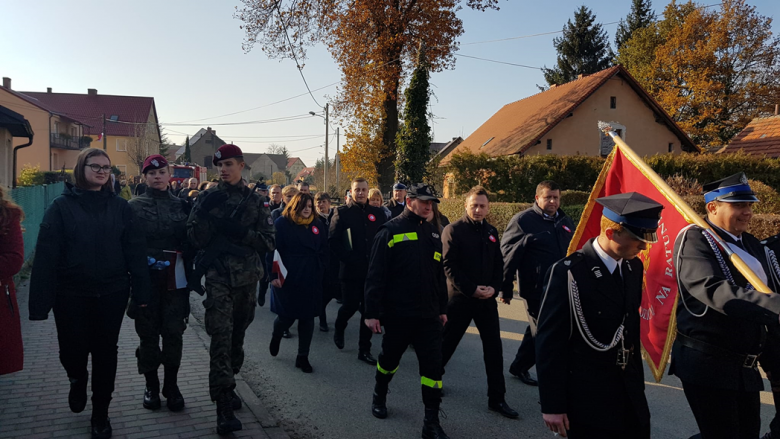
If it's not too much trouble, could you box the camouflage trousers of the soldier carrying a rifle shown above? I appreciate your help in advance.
[203,278,257,401]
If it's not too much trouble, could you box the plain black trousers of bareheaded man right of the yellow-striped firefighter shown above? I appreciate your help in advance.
[441,295,506,402]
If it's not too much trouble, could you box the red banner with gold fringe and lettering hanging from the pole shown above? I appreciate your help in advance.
[569,145,689,382]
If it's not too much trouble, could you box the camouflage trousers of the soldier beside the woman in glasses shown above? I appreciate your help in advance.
[128,278,190,374]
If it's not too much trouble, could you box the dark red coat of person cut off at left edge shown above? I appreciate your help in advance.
[0,210,24,375]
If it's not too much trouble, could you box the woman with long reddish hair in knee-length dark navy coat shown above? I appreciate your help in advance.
[269,193,328,373]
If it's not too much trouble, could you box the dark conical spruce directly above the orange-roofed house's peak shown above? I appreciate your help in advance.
[542,5,612,85]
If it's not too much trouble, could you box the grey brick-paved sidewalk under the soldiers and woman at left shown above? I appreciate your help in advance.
[0,281,289,439]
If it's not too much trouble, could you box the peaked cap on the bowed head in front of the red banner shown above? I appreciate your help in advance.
[596,192,664,244]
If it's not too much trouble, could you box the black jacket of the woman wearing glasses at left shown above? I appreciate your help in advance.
[29,183,151,320]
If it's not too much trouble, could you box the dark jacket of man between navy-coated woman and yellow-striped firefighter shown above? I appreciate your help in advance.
[328,203,387,282]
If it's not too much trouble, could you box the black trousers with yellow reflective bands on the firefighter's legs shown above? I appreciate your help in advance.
[378,317,442,409]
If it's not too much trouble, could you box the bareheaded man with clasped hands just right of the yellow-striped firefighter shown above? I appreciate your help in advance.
[442,186,518,418]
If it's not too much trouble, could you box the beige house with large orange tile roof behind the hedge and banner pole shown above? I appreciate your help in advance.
[441,66,700,165]
